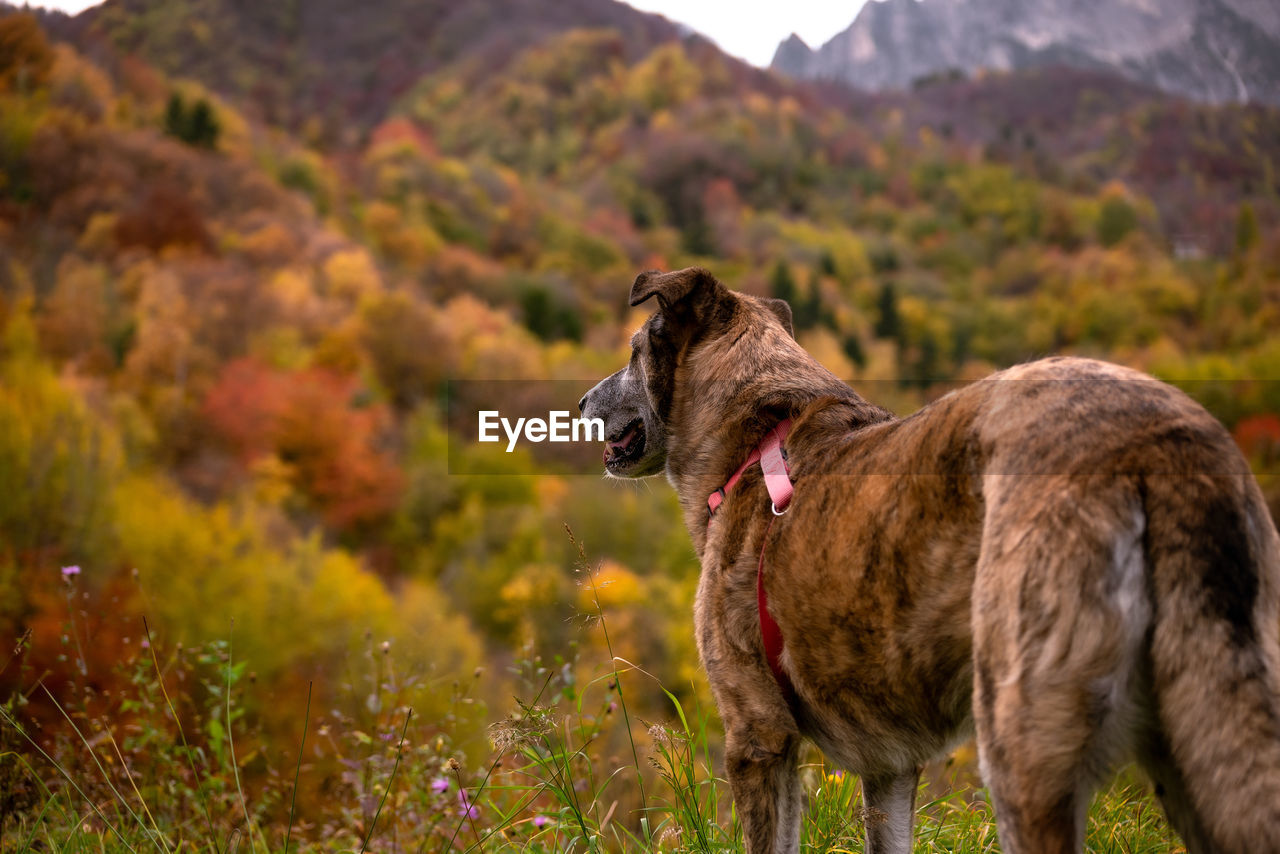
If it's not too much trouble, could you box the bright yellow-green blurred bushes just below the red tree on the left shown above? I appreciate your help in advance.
[113,476,480,714]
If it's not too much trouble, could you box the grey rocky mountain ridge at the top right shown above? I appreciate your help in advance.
[772,0,1280,104]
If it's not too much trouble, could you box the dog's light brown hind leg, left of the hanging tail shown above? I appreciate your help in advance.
[972,478,1149,854]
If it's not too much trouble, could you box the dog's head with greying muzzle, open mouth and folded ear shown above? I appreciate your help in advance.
[579,268,791,478]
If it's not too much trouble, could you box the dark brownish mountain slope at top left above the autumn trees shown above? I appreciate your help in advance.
[35,0,680,142]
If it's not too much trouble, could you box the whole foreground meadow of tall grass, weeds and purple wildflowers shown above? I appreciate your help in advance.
[0,557,1180,854]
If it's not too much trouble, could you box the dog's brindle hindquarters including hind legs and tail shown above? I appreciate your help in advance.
[973,360,1280,851]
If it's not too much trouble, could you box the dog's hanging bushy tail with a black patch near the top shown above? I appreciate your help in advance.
[1143,471,1280,854]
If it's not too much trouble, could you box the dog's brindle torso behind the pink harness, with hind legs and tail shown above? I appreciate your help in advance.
[767,359,1280,851]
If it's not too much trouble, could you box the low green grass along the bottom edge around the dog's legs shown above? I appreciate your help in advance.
[0,671,1179,854]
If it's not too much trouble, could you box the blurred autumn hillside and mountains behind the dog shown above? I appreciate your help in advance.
[0,0,1280,850]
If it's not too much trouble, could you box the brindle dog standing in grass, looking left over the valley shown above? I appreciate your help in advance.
[580,269,1280,854]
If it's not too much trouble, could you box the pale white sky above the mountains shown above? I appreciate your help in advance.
[31,0,865,67]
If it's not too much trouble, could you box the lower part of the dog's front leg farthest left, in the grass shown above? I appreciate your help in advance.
[724,725,800,854]
